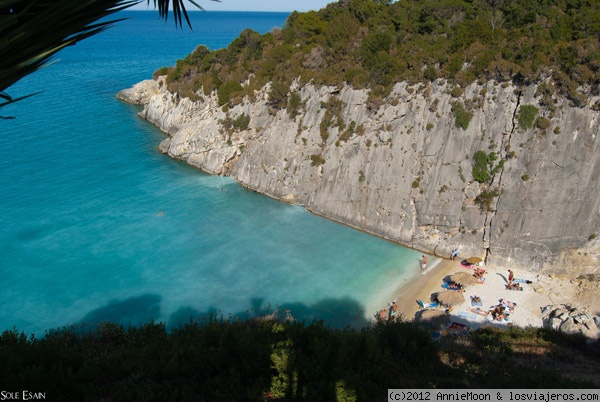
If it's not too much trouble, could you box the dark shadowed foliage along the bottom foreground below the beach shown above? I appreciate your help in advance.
[0,318,600,402]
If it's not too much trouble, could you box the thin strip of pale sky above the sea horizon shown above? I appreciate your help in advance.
[131,0,337,11]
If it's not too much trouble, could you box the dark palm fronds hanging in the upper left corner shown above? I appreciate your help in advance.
[0,0,220,100]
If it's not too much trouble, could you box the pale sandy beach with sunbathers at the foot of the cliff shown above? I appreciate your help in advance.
[382,259,600,334]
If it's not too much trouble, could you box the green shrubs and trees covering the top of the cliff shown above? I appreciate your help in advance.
[155,0,600,109]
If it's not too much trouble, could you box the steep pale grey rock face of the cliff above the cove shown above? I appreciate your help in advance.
[118,78,600,273]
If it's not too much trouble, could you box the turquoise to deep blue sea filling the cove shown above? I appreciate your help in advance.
[0,11,432,336]
